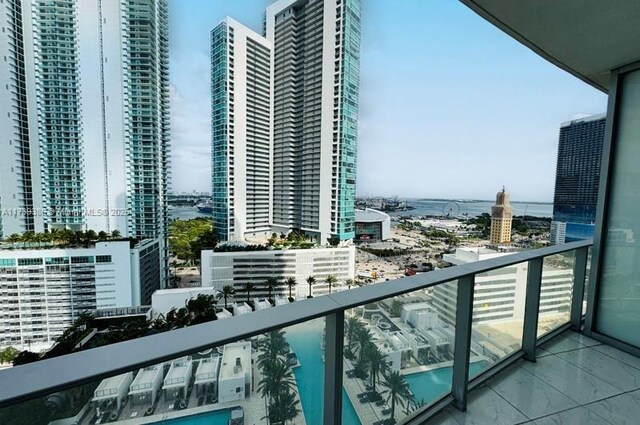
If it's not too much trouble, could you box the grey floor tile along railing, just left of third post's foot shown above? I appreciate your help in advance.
[487,363,578,419]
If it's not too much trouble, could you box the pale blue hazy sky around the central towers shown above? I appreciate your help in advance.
[169,0,606,202]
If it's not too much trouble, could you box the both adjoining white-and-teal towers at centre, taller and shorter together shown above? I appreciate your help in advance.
[211,0,360,243]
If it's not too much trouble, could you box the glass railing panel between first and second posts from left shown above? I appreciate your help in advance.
[342,282,457,425]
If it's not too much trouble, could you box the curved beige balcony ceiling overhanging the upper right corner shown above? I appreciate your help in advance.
[460,0,640,92]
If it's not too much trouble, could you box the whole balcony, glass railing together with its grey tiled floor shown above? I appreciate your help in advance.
[0,241,640,425]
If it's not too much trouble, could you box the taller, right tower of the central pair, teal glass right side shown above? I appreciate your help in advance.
[265,0,360,243]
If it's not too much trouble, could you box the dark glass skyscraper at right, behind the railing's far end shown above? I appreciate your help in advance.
[551,114,605,243]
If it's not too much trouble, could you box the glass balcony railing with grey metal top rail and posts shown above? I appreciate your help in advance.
[0,241,591,425]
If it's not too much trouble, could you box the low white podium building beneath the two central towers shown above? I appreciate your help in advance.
[201,245,356,299]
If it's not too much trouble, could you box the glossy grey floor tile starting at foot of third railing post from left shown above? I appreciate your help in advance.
[522,356,622,404]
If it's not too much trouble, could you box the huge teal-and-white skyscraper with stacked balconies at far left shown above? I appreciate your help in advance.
[0,0,170,282]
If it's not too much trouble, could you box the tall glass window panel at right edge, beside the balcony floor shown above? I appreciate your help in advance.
[596,71,640,347]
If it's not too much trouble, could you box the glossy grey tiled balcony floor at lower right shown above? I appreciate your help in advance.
[429,331,640,425]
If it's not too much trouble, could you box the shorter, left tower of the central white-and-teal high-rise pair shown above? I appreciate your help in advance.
[211,18,272,241]
